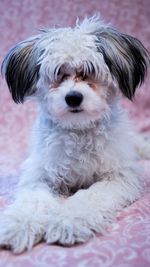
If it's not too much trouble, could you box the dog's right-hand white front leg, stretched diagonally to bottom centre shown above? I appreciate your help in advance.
[45,172,141,245]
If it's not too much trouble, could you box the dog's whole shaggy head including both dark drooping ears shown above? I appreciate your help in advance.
[2,17,149,127]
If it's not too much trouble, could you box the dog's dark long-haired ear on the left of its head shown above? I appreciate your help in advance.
[1,38,40,103]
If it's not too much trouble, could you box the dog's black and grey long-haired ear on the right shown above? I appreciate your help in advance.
[96,27,150,100]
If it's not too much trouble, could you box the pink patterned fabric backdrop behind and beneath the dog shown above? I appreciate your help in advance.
[0,0,150,267]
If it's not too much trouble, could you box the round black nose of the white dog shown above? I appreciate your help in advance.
[65,91,83,108]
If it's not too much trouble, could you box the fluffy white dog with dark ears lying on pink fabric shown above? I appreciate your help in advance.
[0,16,150,253]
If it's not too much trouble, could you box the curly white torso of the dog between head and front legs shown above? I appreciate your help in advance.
[21,105,136,196]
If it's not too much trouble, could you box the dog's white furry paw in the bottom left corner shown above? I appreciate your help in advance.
[0,213,44,253]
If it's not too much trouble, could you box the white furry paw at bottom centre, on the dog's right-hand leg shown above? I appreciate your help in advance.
[45,217,94,246]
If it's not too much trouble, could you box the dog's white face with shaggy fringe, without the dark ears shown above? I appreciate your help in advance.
[37,32,113,128]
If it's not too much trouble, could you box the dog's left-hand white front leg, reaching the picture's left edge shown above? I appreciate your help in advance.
[0,183,59,253]
